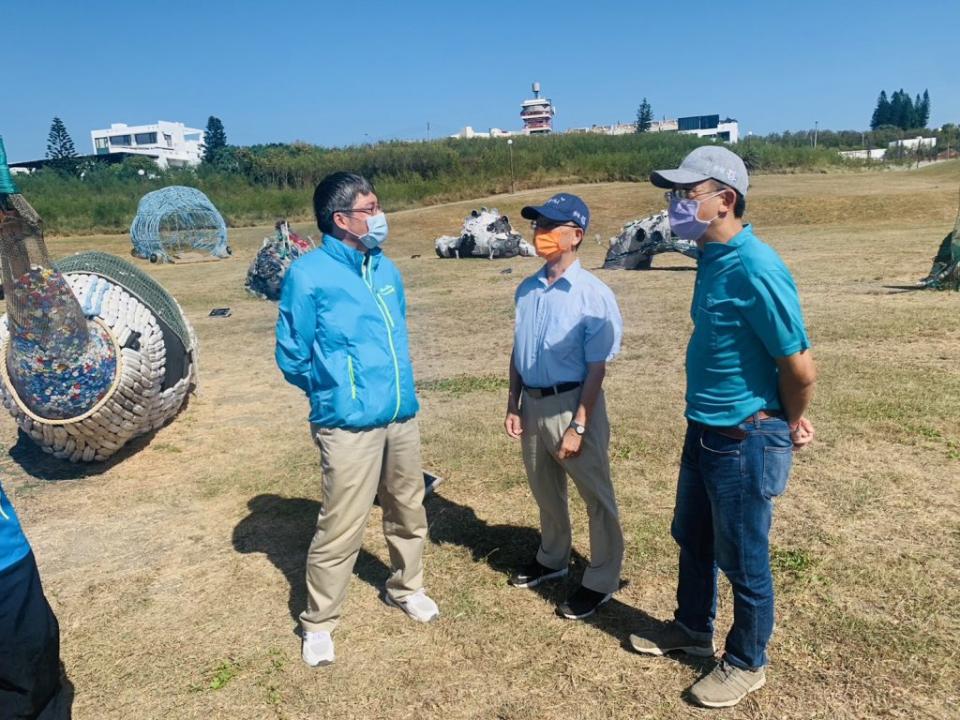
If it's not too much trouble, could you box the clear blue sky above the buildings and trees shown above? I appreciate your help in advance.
[0,0,960,161]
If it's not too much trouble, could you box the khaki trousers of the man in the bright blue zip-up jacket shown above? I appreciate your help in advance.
[300,418,427,632]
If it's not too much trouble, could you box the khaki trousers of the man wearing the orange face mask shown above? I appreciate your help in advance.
[521,391,623,593]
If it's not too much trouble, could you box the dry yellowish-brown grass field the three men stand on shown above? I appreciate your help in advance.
[0,162,960,720]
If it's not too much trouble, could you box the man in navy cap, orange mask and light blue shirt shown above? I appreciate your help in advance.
[504,193,623,619]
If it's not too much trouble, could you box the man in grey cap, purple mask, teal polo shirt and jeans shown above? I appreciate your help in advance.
[629,146,816,708]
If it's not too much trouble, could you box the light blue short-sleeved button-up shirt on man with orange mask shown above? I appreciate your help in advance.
[513,260,623,388]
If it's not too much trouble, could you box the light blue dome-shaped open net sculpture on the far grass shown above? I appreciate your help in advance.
[130,185,231,262]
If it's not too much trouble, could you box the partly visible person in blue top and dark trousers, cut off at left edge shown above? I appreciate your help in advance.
[0,480,70,720]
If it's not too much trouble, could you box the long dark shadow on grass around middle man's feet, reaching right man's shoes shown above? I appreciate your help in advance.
[424,489,714,671]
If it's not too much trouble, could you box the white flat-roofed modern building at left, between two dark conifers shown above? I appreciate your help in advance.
[90,120,204,170]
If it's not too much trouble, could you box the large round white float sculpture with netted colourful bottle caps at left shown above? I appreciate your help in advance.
[0,141,197,462]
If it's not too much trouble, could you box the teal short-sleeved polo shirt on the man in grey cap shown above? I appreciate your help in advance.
[686,225,810,427]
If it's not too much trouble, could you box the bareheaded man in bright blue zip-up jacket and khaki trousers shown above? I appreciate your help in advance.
[276,172,439,666]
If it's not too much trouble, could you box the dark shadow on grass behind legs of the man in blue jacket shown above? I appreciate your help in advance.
[233,494,390,623]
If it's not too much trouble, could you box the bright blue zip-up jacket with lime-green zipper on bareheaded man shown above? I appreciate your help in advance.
[276,235,420,430]
